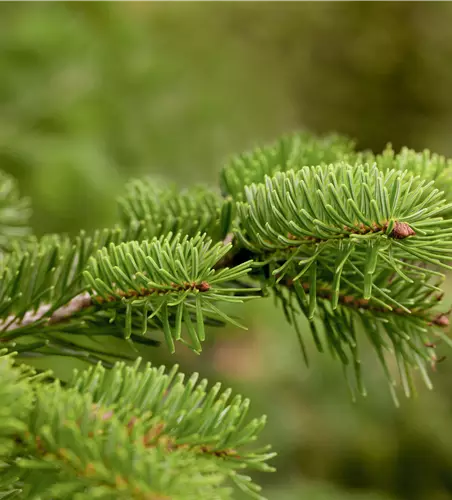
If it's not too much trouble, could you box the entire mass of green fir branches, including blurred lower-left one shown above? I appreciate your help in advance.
[0,133,452,500]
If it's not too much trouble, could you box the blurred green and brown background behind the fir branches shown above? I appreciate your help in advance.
[0,0,452,500]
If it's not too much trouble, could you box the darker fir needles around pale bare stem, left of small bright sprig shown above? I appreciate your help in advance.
[0,222,162,361]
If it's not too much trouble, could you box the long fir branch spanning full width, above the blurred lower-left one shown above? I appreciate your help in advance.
[0,133,452,393]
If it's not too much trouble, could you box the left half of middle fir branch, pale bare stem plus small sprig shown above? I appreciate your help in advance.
[0,229,259,360]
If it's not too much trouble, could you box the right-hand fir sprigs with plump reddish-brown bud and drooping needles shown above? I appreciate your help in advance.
[216,133,452,399]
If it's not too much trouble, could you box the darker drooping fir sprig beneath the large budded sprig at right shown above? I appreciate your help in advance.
[272,274,452,404]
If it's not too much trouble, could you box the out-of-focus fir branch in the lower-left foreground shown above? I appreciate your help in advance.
[0,358,273,500]
